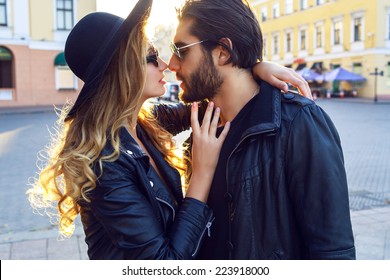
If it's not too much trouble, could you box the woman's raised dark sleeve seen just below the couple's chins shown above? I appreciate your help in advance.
[153,101,208,135]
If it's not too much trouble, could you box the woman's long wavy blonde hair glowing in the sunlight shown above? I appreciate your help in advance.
[27,21,185,237]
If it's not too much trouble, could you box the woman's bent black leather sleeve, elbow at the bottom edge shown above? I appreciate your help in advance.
[90,161,212,259]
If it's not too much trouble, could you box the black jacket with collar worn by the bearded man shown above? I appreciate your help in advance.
[155,82,355,260]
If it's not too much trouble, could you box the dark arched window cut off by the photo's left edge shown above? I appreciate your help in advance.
[0,46,14,100]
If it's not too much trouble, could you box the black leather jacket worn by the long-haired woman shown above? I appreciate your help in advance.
[79,127,212,259]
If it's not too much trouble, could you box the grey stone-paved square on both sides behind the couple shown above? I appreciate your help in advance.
[0,98,390,260]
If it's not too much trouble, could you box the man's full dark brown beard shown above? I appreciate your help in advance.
[179,52,223,103]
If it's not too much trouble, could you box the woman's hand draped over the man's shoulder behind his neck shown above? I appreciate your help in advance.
[252,61,313,99]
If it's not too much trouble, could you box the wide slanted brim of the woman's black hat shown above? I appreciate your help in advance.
[65,0,153,121]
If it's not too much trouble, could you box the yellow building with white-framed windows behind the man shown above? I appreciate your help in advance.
[250,0,390,98]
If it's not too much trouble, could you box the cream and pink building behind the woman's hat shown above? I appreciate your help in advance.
[0,0,96,107]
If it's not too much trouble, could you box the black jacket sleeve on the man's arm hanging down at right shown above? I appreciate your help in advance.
[286,105,356,260]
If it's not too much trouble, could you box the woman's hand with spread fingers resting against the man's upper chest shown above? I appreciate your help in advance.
[186,102,230,202]
